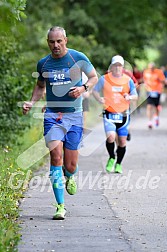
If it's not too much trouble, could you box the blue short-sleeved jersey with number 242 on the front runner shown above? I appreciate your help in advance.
[37,49,93,113]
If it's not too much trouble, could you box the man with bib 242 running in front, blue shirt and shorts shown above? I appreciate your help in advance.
[23,27,98,219]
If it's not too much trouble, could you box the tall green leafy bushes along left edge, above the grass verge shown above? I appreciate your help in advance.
[0,0,31,146]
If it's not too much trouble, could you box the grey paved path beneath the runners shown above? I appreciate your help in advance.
[18,109,167,252]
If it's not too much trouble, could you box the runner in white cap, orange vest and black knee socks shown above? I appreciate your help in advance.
[92,55,138,173]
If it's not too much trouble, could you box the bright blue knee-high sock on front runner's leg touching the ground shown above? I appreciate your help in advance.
[50,165,64,204]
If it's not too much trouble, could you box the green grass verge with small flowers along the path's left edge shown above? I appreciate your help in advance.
[0,110,44,252]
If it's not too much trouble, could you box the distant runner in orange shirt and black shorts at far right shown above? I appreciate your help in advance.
[143,63,165,129]
